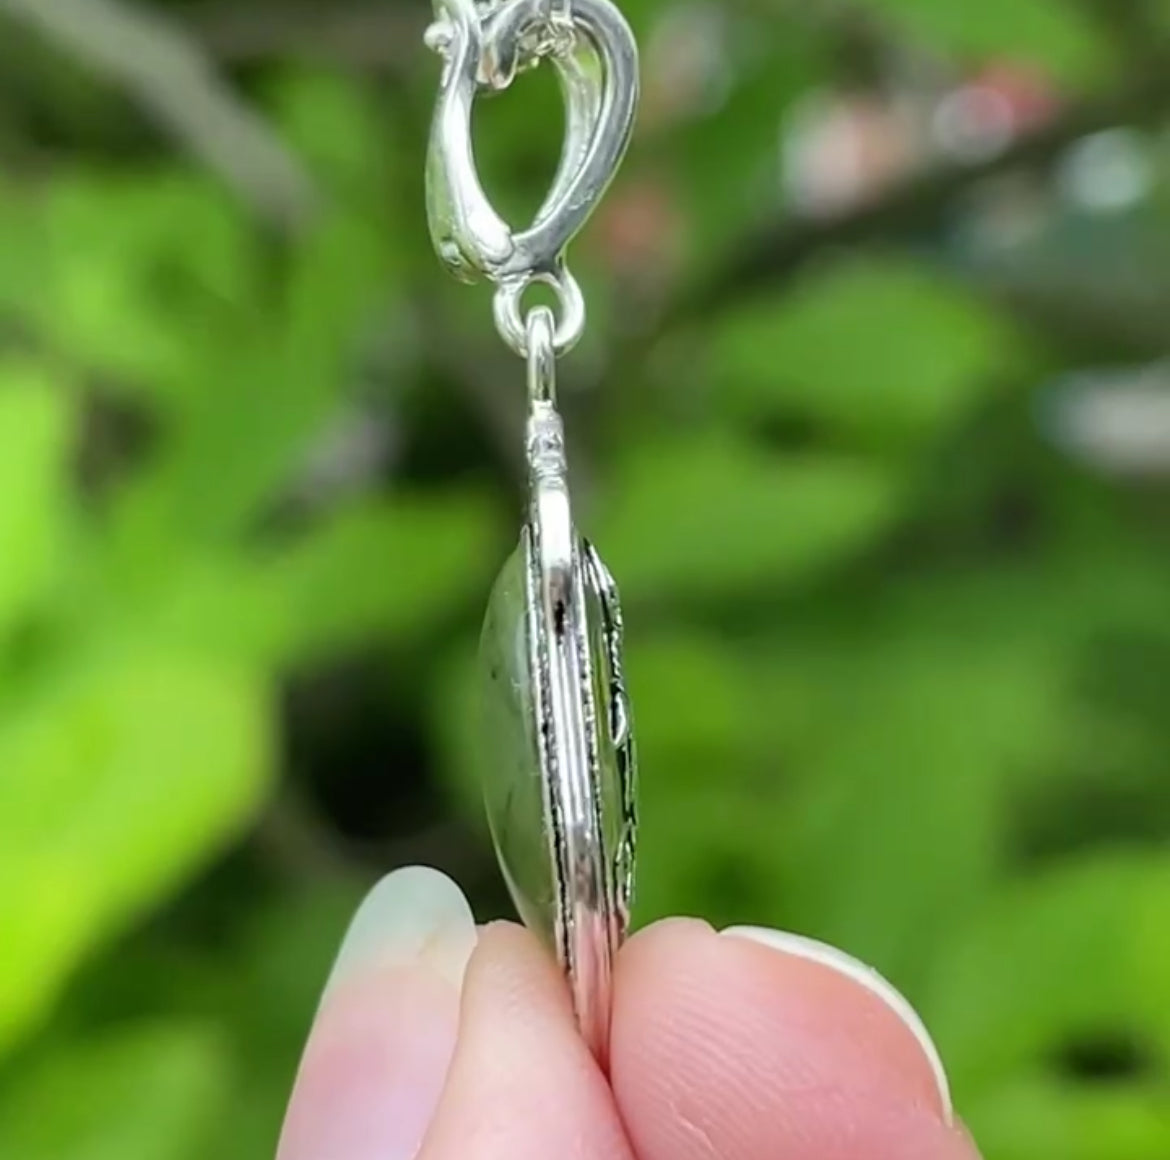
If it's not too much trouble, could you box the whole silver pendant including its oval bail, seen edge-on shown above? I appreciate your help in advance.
[427,0,638,1062]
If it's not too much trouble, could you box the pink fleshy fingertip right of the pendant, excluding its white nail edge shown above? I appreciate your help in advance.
[611,921,973,1160]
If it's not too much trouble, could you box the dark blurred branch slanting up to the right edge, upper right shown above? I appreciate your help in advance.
[662,65,1170,329]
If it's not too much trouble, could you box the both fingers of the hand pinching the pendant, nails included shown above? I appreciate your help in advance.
[277,867,977,1160]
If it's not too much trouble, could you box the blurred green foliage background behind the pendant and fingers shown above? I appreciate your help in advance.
[0,0,1170,1160]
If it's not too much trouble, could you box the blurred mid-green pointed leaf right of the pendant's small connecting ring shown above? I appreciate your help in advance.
[701,258,1032,448]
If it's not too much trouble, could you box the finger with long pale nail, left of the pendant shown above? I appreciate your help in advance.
[277,867,633,1160]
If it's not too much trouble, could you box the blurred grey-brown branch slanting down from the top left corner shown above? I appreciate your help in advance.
[0,0,316,226]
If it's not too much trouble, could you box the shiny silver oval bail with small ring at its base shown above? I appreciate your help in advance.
[427,0,638,352]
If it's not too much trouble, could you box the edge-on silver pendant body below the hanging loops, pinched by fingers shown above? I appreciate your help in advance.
[480,372,636,1057]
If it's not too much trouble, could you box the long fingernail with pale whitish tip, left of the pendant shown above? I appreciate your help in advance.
[277,866,476,1160]
